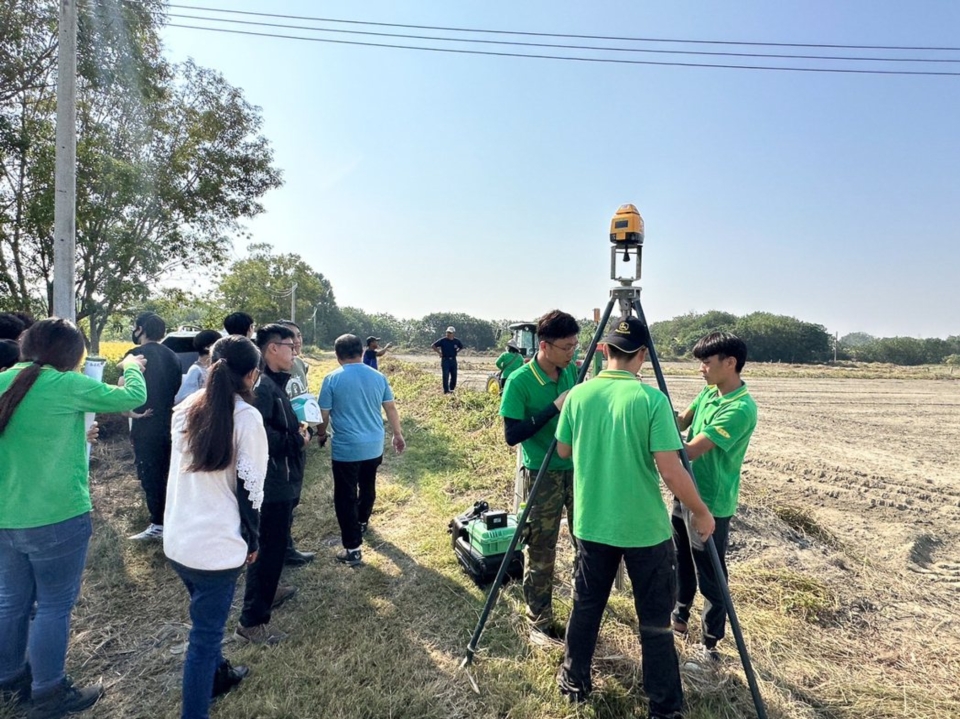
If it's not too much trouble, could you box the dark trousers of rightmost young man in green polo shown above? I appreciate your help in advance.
[671,516,730,647]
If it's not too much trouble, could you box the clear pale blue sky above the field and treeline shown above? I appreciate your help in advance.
[163,0,960,337]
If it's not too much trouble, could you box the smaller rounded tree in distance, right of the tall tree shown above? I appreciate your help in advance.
[217,243,343,344]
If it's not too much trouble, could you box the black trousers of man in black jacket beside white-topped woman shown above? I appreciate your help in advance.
[240,501,293,627]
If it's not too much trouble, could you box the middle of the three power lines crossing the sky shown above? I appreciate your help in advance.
[168,13,960,63]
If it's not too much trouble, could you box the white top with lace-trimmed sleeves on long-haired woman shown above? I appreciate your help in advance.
[163,392,268,571]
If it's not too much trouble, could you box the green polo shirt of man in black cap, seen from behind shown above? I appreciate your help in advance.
[557,370,681,547]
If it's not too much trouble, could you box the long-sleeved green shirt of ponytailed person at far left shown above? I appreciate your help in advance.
[0,362,147,529]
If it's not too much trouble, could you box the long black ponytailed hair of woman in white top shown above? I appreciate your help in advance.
[184,335,260,472]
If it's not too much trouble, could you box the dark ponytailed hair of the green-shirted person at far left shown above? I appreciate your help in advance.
[0,317,86,434]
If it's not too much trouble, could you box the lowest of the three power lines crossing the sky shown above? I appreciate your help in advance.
[168,23,960,77]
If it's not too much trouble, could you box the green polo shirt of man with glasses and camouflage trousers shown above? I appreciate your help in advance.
[500,357,577,471]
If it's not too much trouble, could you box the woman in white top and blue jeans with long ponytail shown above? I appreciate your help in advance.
[163,336,268,718]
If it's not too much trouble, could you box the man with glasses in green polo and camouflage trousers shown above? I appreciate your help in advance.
[500,310,580,638]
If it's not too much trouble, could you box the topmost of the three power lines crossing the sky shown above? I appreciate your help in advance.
[169,3,960,52]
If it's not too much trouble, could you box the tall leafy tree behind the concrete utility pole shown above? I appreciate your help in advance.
[0,0,280,351]
